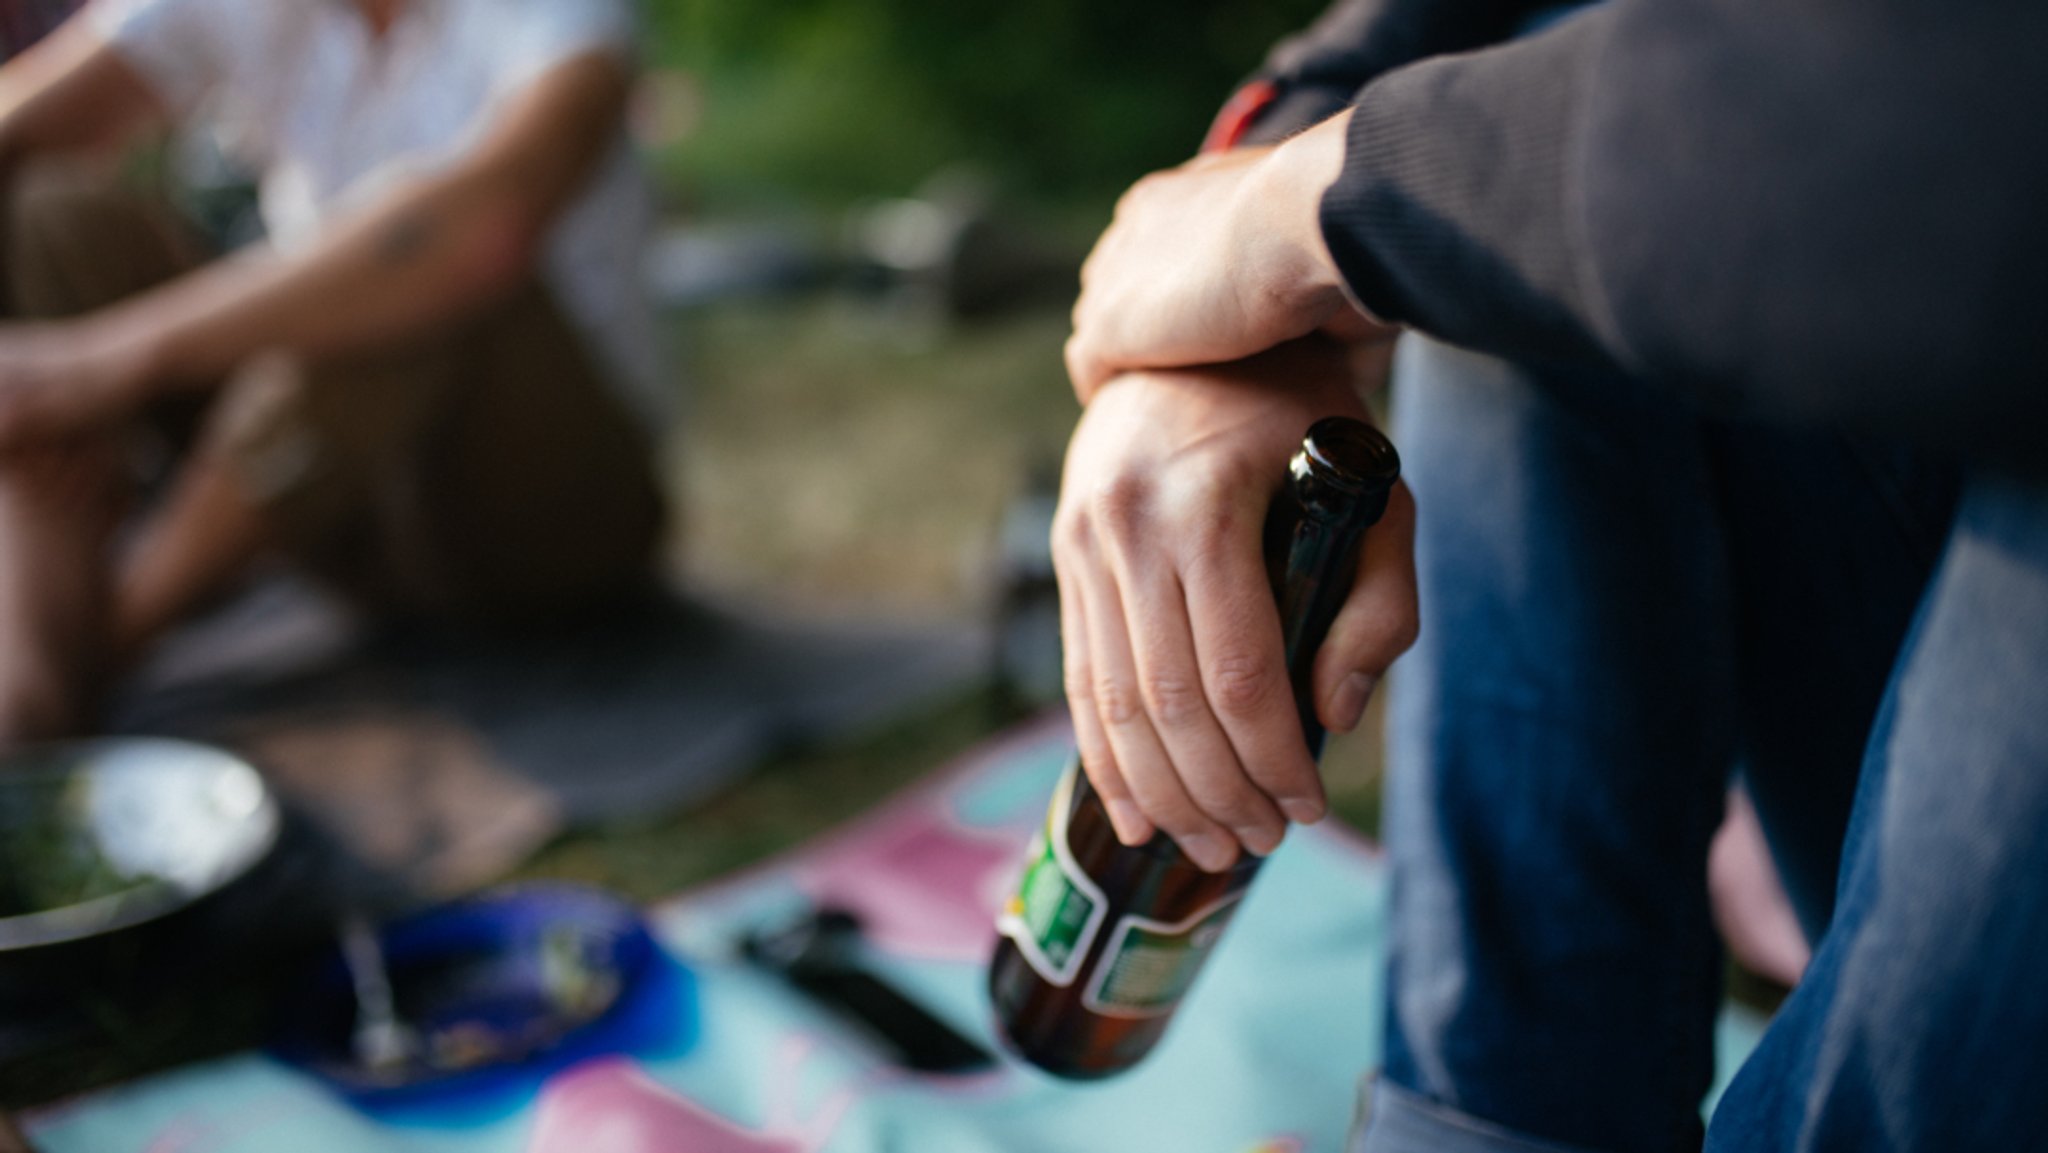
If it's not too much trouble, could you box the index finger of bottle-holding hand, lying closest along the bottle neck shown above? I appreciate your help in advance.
[1182,508,1329,825]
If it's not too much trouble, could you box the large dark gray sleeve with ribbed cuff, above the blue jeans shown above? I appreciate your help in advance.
[1323,0,2048,471]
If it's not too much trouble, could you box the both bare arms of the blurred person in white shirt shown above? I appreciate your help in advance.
[0,20,631,449]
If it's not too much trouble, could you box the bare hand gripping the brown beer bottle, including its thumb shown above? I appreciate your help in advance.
[1053,338,1417,870]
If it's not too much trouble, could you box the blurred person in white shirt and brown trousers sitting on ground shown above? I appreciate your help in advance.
[0,0,666,745]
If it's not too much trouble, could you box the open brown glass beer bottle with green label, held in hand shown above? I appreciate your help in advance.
[989,418,1401,1079]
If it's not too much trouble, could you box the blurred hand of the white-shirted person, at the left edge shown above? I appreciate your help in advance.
[0,322,150,451]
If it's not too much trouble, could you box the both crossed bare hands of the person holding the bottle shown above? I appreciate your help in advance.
[1053,110,1417,870]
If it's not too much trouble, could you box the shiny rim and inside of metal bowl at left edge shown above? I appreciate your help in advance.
[0,737,283,960]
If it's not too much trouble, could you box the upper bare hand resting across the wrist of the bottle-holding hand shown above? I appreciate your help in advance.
[1067,113,1395,403]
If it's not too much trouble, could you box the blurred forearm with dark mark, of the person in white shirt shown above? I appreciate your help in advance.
[88,168,545,387]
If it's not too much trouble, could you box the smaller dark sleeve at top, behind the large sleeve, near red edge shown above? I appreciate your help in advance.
[1245,0,1536,143]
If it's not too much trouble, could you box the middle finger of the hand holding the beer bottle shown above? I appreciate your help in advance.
[1112,545,1286,856]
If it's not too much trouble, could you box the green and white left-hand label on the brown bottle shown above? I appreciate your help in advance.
[995,762,1110,989]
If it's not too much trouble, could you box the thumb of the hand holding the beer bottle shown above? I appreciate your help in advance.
[1315,483,1421,733]
